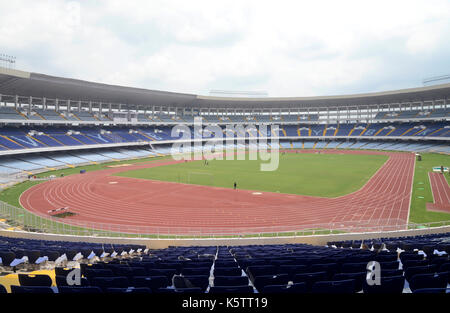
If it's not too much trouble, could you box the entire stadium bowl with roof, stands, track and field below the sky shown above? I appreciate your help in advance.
[0,1,450,297]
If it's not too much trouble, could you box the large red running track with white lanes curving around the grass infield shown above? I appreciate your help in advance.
[20,150,415,234]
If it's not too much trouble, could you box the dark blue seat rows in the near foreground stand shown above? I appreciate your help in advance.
[0,233,450,294]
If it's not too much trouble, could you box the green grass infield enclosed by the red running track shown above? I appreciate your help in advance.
[117,153,388,198]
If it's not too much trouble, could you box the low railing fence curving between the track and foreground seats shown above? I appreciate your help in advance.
[0,201,450,238]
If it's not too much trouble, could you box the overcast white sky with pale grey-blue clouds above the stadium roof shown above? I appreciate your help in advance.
[0,0,450,97]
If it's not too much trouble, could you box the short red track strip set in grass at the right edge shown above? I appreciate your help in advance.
[427,172,450,213]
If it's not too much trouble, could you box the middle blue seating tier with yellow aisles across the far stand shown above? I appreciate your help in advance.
[0,120,450,151]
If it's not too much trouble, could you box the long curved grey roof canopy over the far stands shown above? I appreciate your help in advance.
[0,68,450,109]
